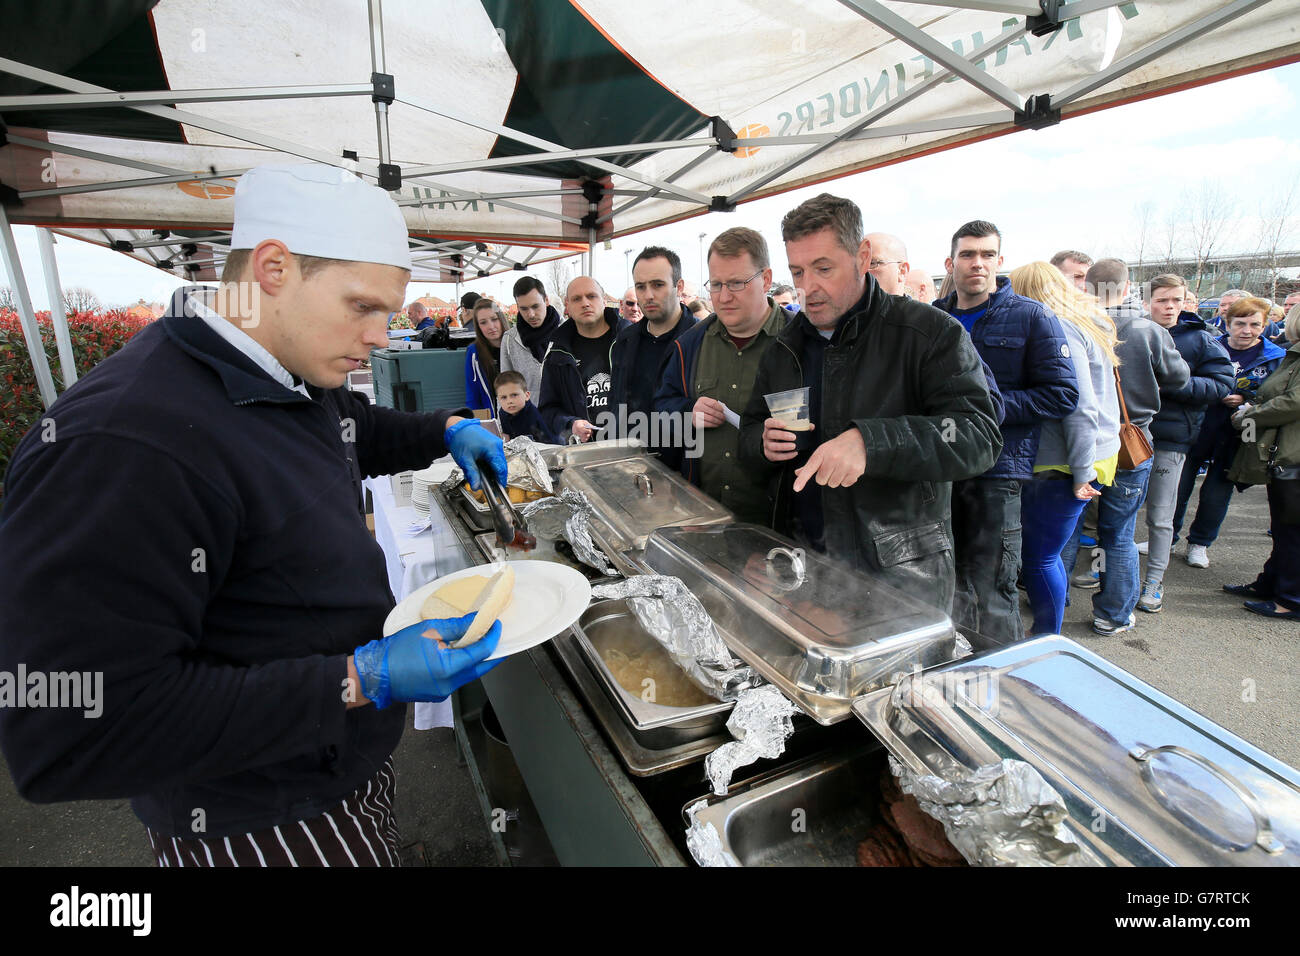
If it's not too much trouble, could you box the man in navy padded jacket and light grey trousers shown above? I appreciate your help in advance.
[1138,273,1234,614]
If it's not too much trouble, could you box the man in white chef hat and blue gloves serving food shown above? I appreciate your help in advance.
[0,165,506,866]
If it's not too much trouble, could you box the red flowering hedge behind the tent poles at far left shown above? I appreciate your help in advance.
[0,308,150,494]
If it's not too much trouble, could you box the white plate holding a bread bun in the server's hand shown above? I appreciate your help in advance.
[384,561,592,661]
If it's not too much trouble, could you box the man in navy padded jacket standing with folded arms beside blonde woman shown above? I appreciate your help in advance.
[935,220,1079,649]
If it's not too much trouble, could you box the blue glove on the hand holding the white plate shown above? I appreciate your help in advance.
[352,614,506,710]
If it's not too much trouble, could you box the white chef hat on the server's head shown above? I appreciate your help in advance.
[230,163,411,269]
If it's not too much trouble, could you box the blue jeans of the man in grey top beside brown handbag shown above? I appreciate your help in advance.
[1061,458,1153,624]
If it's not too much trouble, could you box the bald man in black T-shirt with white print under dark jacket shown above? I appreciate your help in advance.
[537,276,632,441]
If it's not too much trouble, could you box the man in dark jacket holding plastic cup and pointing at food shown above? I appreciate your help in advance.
[741,193,1002,613]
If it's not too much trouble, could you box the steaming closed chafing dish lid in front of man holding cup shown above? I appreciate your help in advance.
[642,524,956,724]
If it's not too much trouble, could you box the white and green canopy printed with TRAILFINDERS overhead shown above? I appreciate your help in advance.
[0,0,1300,403]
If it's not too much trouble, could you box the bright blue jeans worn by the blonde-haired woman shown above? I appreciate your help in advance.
[1021,475,1087,637]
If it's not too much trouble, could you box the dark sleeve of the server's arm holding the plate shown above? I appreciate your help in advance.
[0,434,347,803]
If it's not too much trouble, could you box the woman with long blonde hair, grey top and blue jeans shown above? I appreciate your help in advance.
[1011,261,1119,635]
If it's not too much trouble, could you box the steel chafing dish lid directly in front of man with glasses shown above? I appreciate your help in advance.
[560,454,735,550]
